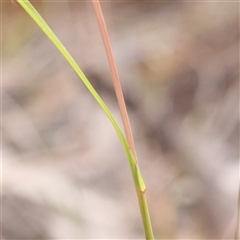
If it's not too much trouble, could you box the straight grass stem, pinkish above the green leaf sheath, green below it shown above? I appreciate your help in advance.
[92,0,154,239]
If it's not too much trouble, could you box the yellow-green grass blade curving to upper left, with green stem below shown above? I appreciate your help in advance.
[17,0,153,240]
